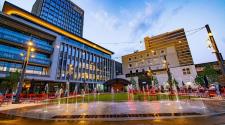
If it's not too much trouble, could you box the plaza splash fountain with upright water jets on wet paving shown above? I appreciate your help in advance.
[0,81,224,120]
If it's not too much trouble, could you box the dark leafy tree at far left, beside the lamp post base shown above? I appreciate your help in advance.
[0,71,20,91]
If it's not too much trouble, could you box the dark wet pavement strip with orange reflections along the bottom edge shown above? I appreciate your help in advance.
[0,114,225,125]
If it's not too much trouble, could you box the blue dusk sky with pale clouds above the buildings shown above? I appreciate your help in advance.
[0,0,225,64]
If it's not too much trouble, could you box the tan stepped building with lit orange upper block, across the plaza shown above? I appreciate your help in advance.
[122,29,197,84]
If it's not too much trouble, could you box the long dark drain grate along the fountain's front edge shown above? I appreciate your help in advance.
[52,112,201,119]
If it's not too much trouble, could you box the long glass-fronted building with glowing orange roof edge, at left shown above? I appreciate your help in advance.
[0,2,115,92]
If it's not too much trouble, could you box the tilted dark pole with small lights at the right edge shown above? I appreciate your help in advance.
[205,24,225,75]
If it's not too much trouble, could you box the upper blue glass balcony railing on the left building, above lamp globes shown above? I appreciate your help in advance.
[0,30,53,52]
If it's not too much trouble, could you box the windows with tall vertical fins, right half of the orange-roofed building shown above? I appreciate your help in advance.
[57,44,114,82]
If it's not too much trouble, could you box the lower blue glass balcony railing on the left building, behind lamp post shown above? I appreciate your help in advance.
[0,50,51,65]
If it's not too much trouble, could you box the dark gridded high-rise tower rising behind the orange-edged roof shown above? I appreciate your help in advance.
[32,0,84,37]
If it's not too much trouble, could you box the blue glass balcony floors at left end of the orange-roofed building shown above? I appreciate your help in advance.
[0,26,53,75]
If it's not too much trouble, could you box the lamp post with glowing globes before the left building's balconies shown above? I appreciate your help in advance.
[15,40,35,103]
